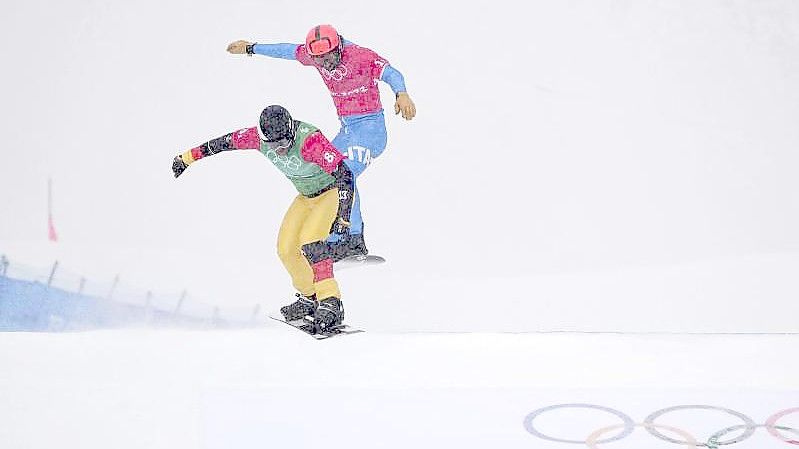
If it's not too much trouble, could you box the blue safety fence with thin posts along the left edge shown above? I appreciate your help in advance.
[0,255,260,332]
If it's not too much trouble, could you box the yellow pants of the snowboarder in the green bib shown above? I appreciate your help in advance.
[277,189,341,300]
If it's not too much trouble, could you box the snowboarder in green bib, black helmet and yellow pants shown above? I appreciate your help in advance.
[172,105,355,333]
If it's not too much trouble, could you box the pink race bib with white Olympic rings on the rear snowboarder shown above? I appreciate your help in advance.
[295,43,388,116]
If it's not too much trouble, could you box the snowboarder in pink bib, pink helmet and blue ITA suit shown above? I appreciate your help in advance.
[227,25,416,260]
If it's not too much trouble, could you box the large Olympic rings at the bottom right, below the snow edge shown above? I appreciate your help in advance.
[524,404,799,449]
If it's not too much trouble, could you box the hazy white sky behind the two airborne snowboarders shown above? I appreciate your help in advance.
[0,0,799,324]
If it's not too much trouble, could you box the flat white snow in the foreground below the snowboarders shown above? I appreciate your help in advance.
[0,323,799,449]
